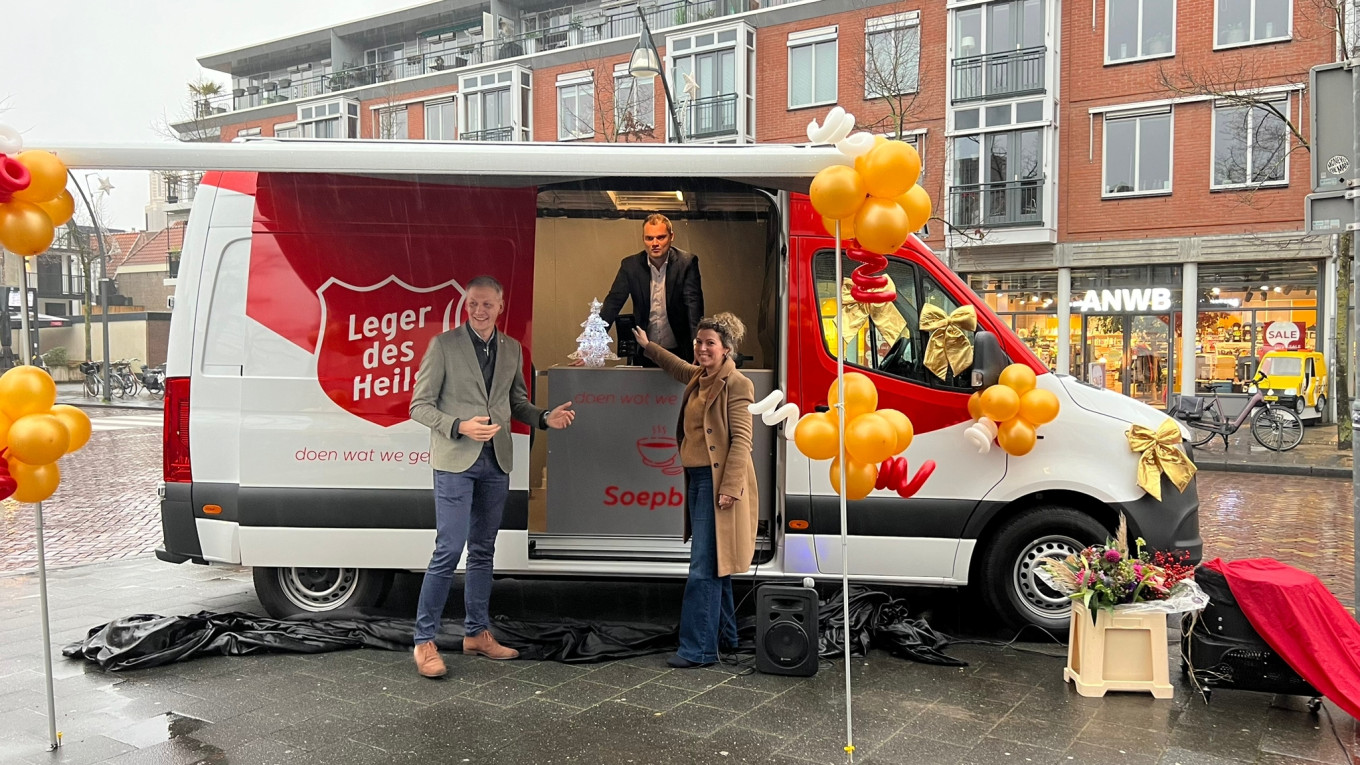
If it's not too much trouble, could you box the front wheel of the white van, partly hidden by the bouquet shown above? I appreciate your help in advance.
[978,505,1110,638]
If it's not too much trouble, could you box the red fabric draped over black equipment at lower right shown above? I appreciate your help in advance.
[1204,558,1360,719]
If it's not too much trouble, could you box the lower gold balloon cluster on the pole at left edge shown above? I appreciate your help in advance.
[0,366,90,502]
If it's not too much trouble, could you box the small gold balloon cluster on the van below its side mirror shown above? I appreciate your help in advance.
[964,363,1058,457]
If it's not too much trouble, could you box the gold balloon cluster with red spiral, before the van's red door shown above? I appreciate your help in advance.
[793,372,934,500]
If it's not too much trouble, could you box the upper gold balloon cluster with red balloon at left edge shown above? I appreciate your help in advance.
[0,125,76,257]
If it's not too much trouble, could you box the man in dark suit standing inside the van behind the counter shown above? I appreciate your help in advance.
[600,212,703,366]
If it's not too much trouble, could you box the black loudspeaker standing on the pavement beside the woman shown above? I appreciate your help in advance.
[756,585,817,677]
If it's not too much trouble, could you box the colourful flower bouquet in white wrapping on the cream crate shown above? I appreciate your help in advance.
[1039,516,1209,614]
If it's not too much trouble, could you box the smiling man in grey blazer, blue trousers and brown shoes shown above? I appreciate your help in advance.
[411,276,575,678]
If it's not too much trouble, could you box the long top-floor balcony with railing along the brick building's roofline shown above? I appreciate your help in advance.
[204,0,756,112]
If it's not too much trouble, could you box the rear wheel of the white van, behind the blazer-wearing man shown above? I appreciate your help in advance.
[254,566,392,619]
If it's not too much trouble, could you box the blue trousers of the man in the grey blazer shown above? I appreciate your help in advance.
[415,444,510,644]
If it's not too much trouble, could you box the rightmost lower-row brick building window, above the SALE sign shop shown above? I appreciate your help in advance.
[1213,95,1289,188]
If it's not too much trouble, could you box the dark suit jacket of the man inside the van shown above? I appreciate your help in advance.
[600,246,703,358]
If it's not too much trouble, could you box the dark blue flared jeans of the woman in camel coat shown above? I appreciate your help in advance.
[676,467,737,664]
